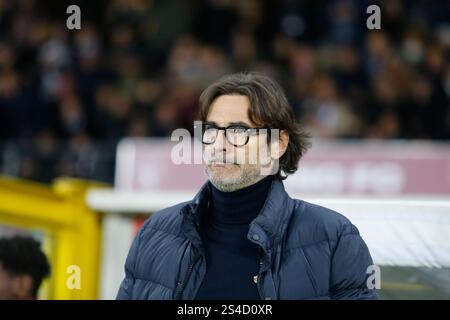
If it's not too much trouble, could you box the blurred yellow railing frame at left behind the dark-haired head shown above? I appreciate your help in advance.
[0,177,108,299]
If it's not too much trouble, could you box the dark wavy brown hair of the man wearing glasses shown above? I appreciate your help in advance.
[198,72,311,180]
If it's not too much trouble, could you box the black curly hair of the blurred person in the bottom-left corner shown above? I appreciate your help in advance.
[0,236,50,296]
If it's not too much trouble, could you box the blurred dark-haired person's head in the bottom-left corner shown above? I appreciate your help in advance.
[0,236,50,300]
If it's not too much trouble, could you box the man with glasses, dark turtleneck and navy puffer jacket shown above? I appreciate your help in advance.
[117,73,377,300]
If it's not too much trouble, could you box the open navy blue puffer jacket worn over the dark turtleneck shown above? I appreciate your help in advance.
[117,180,377,300]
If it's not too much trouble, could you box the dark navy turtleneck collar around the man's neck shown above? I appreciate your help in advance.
[209,176,273,225]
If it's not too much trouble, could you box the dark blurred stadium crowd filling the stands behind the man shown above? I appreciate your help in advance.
[0,0,450,182]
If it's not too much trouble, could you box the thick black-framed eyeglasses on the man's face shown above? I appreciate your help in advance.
[194,123,270,147]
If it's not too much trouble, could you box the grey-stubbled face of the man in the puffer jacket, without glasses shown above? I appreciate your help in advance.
[204,95,267,192]
